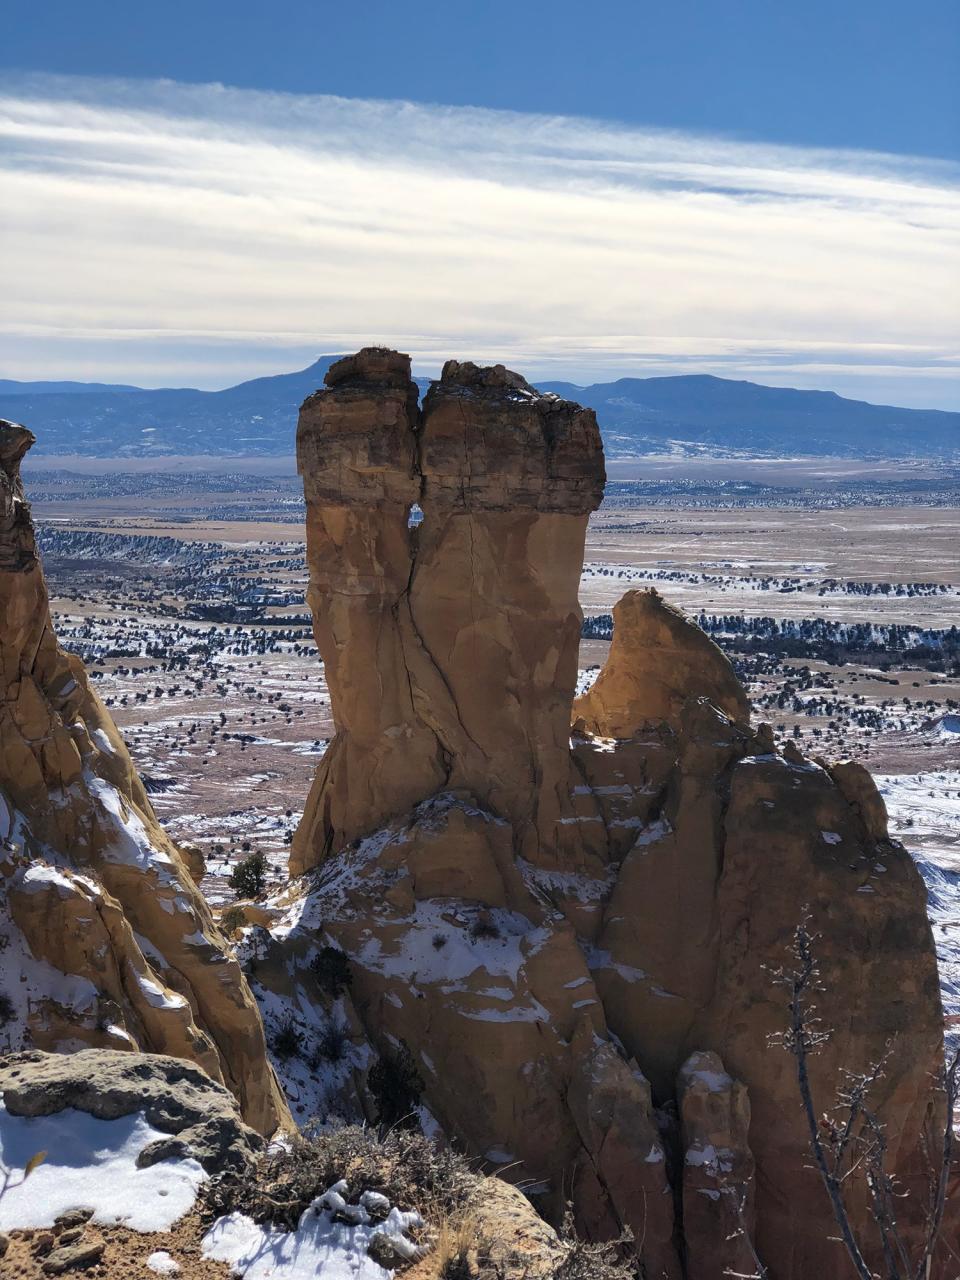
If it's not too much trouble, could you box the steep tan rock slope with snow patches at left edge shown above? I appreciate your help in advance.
[0,421,288,1133]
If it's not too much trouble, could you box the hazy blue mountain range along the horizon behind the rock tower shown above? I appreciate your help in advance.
[0,356,960,461]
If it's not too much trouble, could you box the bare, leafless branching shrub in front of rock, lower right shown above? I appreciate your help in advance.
[773,916,960,1280]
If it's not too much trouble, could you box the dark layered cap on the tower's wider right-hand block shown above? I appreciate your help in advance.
[420,360,605,516]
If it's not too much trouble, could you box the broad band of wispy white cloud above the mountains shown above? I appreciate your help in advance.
[0,77,960,407]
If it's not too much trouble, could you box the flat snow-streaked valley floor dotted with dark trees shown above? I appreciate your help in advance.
[27,460,960,1049]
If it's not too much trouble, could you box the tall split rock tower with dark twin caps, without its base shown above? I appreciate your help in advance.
[291,348,604,874]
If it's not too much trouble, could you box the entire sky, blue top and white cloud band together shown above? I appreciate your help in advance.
[0,0,960,407]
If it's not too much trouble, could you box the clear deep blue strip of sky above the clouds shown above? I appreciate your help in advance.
[7,0,960,159]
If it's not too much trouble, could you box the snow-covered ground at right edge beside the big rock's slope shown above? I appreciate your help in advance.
[876,769,960,1041]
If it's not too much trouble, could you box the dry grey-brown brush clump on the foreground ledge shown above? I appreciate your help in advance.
[202,1125,477,1230]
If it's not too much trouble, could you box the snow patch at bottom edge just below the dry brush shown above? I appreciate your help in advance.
[201,1183,422,1280]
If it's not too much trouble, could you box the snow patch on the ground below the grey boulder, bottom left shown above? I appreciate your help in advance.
[0,1102,206,1231]
